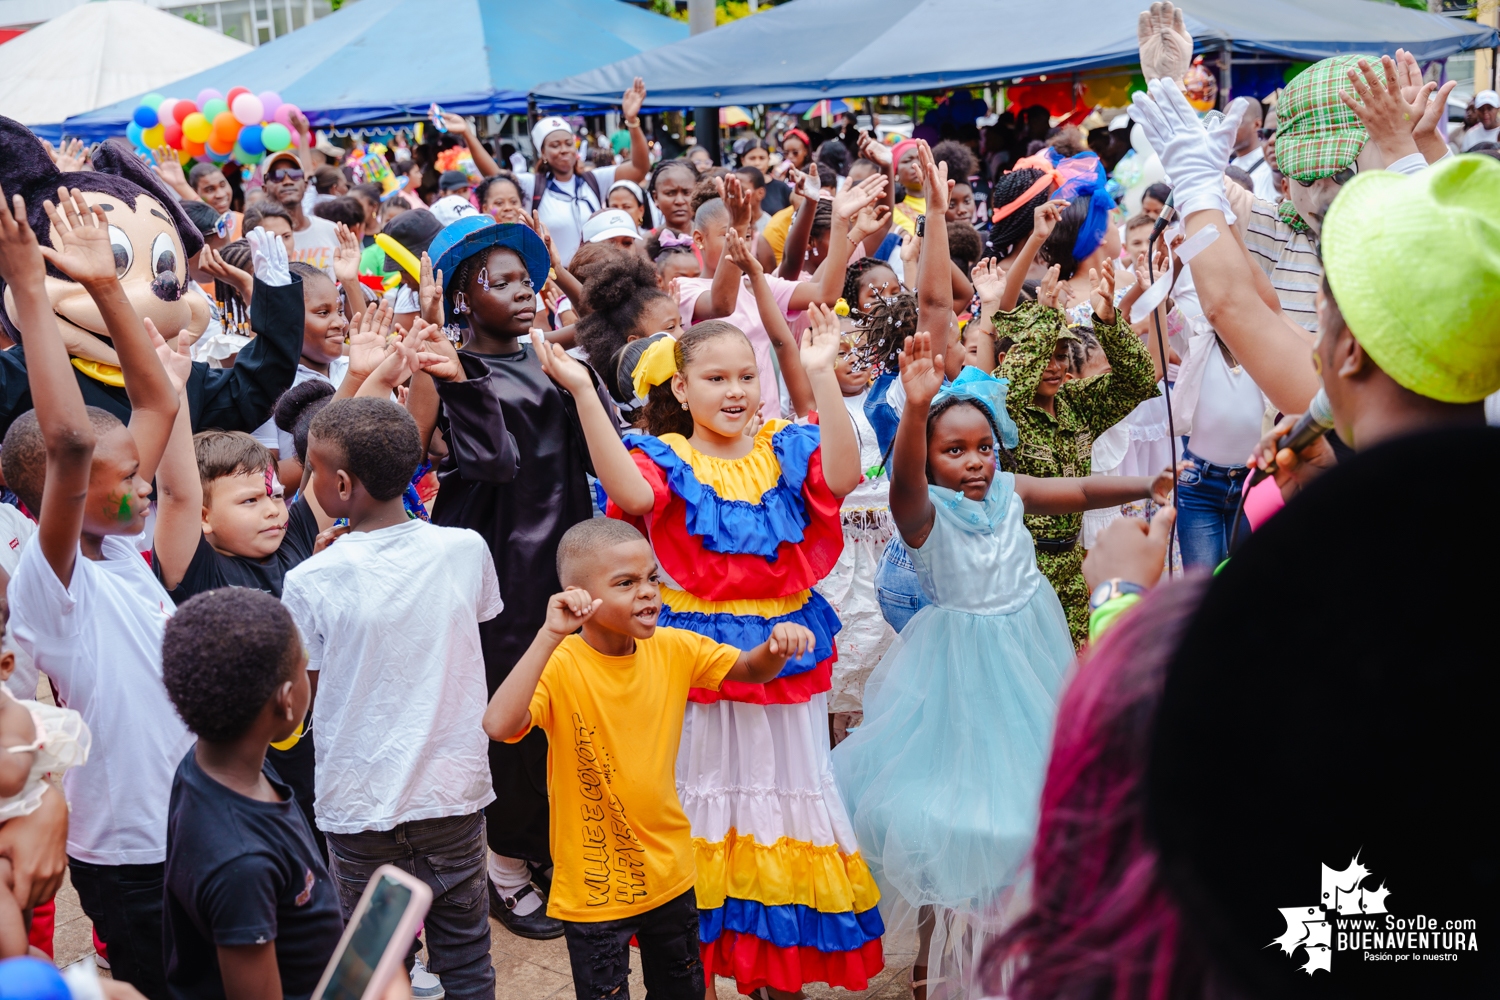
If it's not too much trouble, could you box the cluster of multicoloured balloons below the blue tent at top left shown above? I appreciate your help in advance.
[125,87,299,166]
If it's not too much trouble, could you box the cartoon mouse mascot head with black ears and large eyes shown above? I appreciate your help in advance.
[0,110,209,374]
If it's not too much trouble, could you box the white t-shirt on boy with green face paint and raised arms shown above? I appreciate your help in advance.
[9,535,194,865]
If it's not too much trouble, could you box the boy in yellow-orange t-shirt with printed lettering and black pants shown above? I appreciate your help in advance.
[485,517,813,1000]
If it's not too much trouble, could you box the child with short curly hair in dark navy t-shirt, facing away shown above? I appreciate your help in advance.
[162,588,344,997]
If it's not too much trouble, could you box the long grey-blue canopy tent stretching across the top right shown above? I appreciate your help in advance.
[534,0,1500,106]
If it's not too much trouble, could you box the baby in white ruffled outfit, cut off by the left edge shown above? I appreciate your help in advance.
[0,581,90,958]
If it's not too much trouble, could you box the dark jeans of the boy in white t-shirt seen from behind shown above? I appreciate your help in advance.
[327,811,495,1000]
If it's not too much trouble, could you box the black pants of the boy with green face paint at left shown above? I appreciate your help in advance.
[68,858,167,1000]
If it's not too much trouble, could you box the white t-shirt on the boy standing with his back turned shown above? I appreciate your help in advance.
[282,520,503,834]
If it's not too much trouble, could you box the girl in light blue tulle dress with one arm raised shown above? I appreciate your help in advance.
[833,334,1172,996]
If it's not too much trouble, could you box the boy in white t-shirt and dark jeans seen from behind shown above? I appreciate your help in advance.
[282,397,501,1000]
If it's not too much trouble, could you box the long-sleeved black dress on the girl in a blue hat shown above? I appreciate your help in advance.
[432,343,612,867]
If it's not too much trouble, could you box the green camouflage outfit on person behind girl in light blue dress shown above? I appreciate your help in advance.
[995,303,1161,645]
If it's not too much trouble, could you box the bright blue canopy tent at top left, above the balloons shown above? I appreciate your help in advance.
[62,0,687,139]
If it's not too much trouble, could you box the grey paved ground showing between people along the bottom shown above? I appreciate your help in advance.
[53,882,912,1000]
